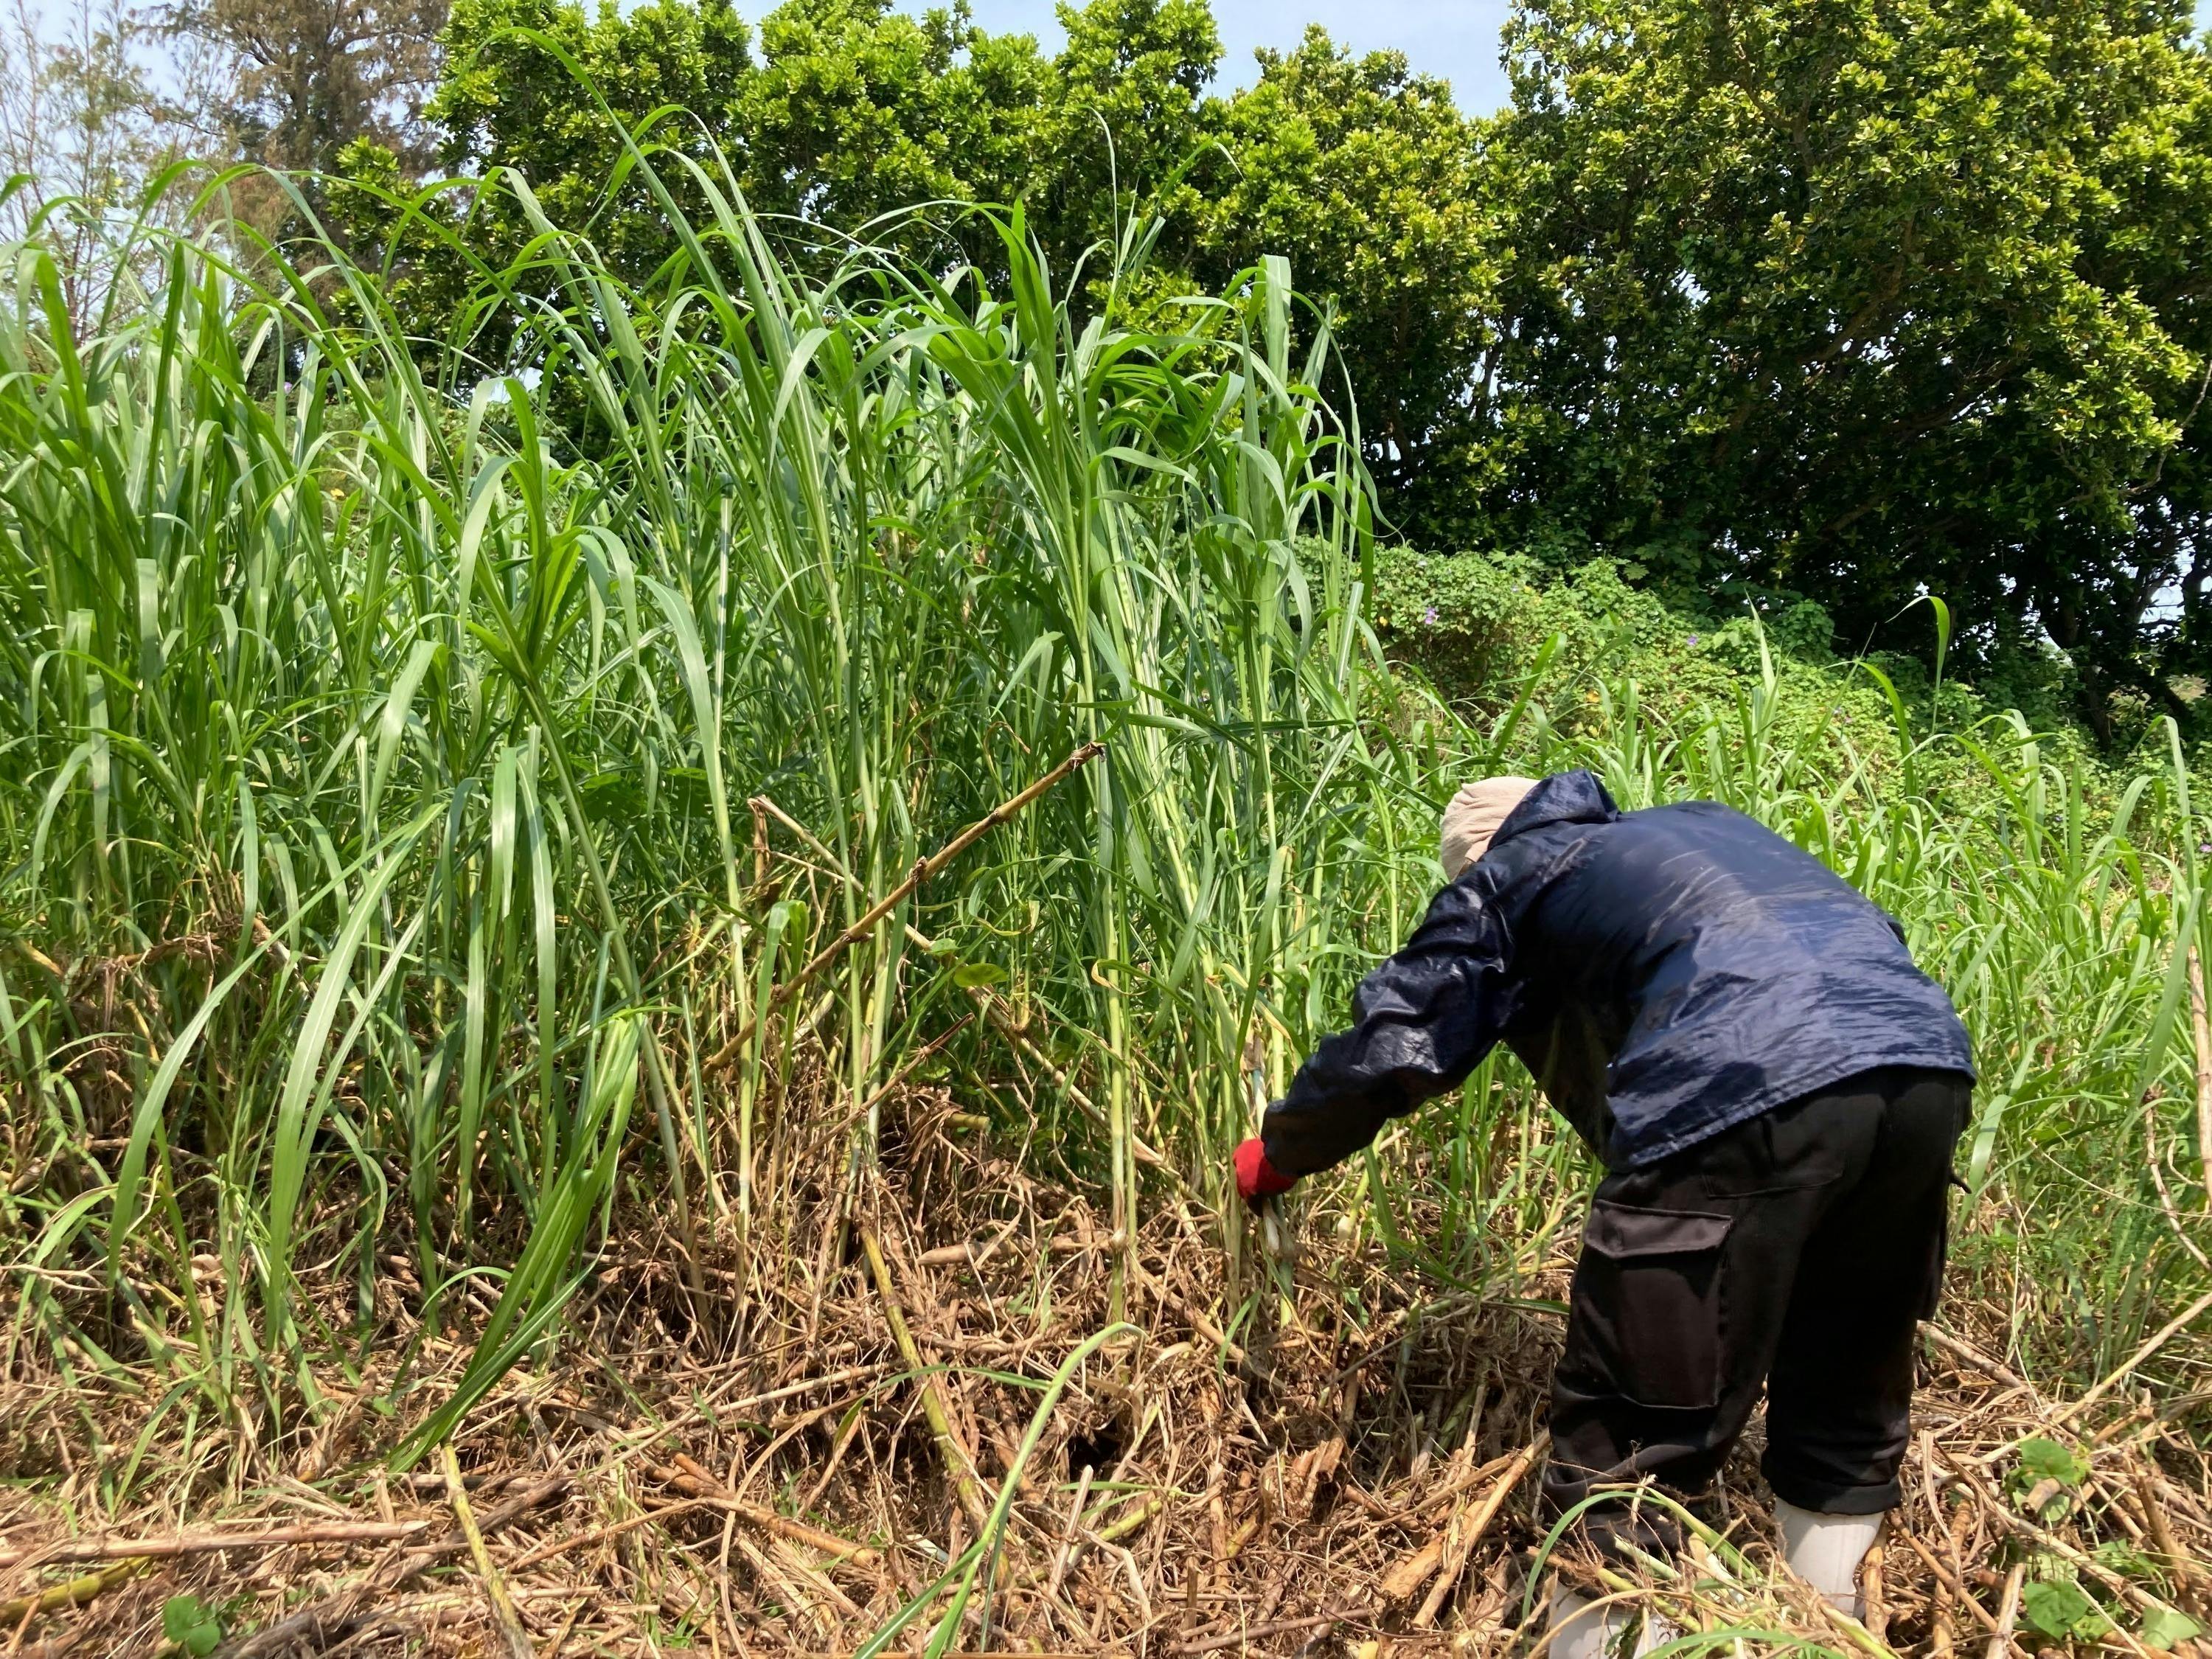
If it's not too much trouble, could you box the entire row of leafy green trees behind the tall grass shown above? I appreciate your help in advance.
[307,0,2212,734]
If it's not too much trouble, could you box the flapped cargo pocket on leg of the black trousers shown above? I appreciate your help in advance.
[1559,1199,1734,1411]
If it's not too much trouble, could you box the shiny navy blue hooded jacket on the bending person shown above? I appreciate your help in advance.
[1261,772,1973,1175]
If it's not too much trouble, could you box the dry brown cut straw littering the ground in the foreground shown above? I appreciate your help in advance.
[0,1088,2212,1659]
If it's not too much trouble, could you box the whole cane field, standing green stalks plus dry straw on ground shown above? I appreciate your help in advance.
[0,146,2212,1659]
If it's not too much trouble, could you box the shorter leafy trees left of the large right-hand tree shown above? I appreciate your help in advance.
[347,0,1495,471]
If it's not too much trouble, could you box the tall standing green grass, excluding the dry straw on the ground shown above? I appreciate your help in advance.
[0,136,2205,1478]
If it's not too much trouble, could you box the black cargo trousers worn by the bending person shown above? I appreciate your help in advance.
[1544,1066,1971,1553]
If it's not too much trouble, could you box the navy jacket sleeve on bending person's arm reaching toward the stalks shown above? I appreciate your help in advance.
[1261,883,1513,1179]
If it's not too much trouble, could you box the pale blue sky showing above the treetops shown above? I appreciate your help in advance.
[909,0,2212,113]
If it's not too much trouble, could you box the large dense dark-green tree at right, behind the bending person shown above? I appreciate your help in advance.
[1486,0,2212,734]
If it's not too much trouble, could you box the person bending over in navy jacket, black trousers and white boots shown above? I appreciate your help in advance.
[1237,772,1973,1659]
